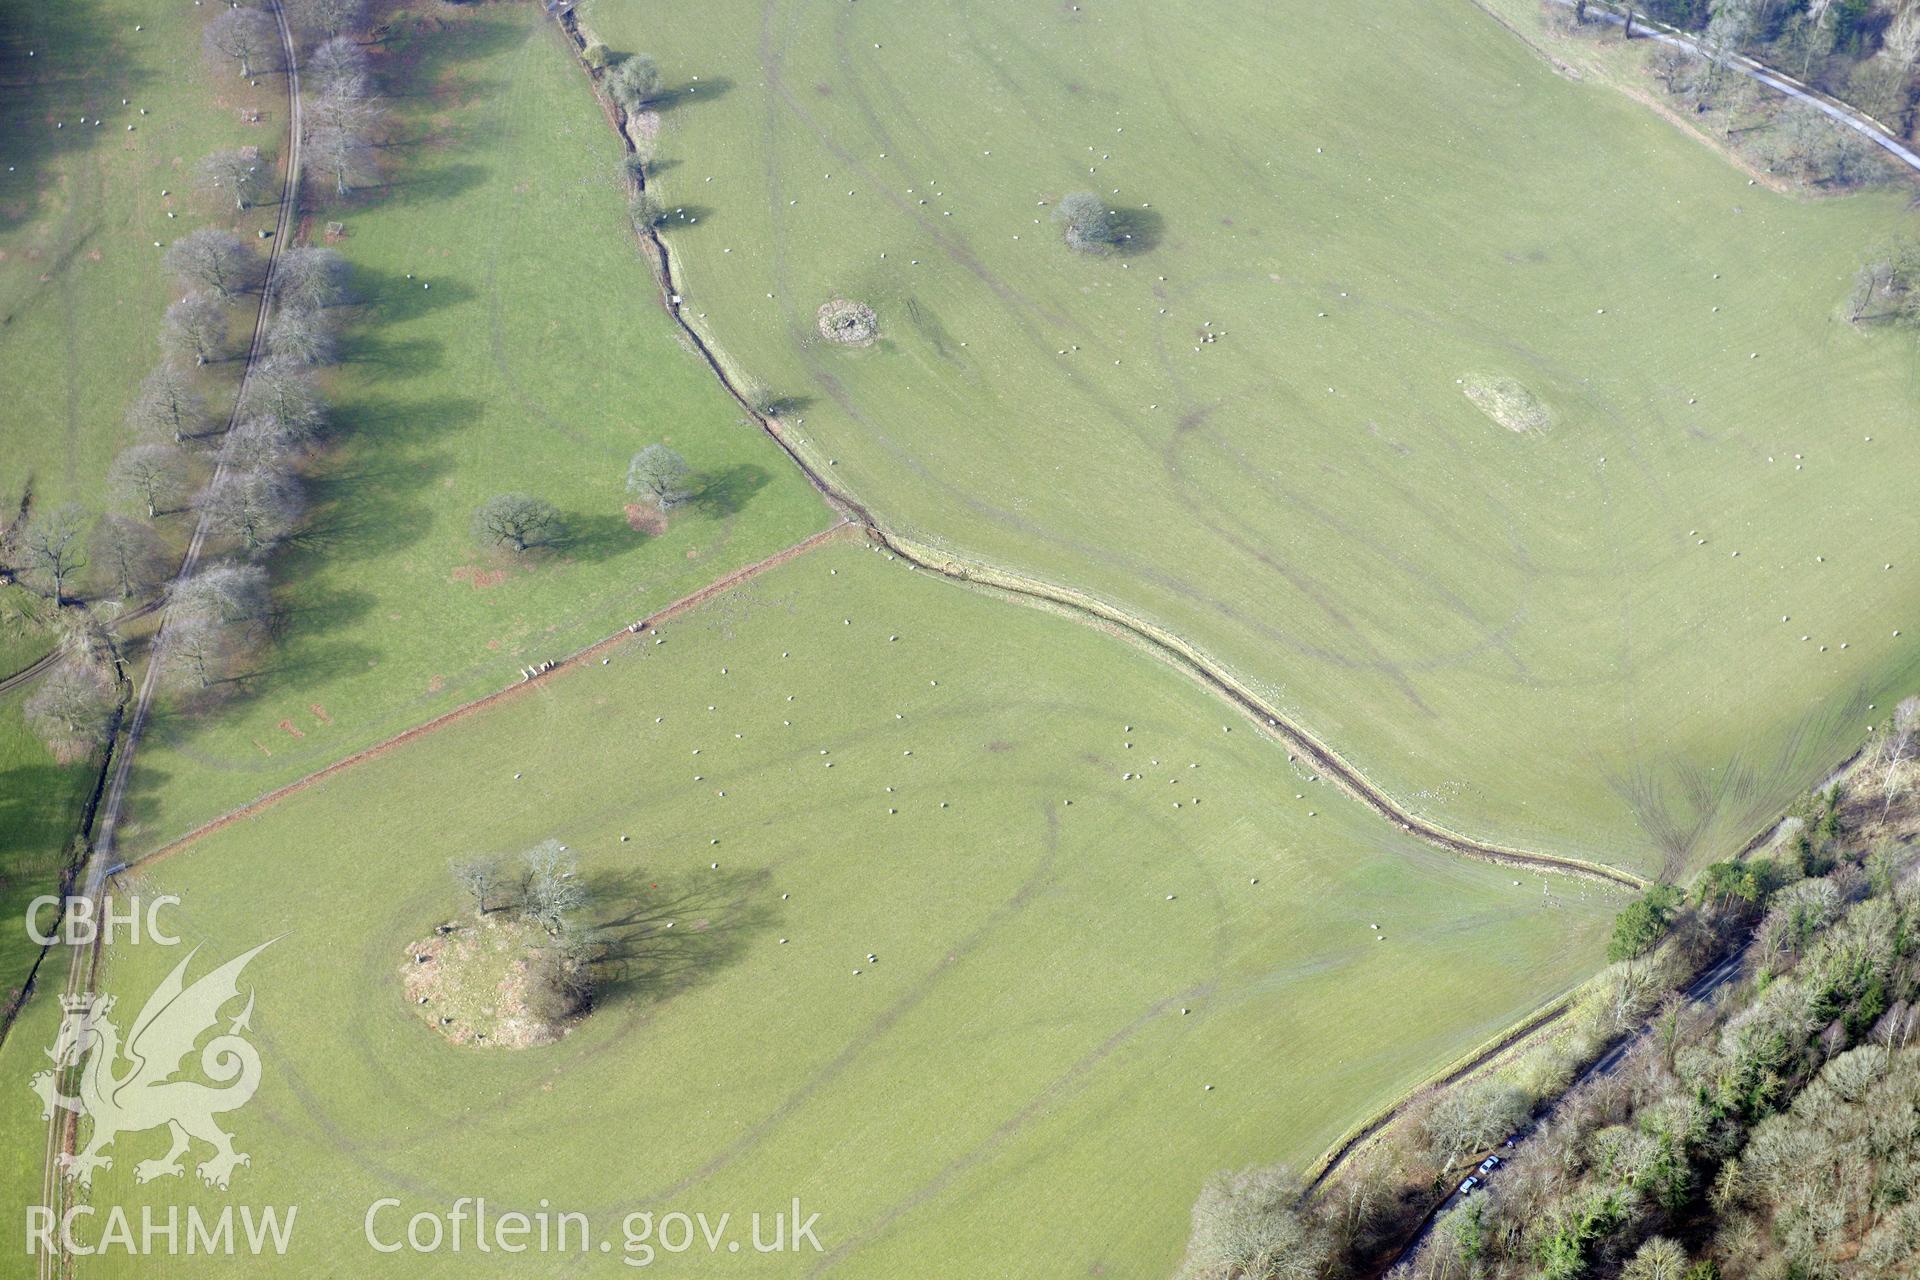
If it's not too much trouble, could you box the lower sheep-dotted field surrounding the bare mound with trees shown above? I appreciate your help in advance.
[63,543,1620,1278]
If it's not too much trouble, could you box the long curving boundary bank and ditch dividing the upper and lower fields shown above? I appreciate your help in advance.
[559,10,1647,892]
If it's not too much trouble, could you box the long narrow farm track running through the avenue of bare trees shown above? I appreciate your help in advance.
[38,0,303,1280]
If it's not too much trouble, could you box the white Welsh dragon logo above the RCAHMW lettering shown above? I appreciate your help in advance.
[33,938,273,1190]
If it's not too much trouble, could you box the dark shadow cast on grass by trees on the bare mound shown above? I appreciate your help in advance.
[586,871,778,1004]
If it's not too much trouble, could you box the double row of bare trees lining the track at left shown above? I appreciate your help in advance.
[0,0,380,758]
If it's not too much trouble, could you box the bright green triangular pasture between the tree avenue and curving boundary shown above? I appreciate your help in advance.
[121,4,829,850]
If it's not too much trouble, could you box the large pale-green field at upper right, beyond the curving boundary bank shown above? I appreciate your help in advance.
[582,0,1920,873]
